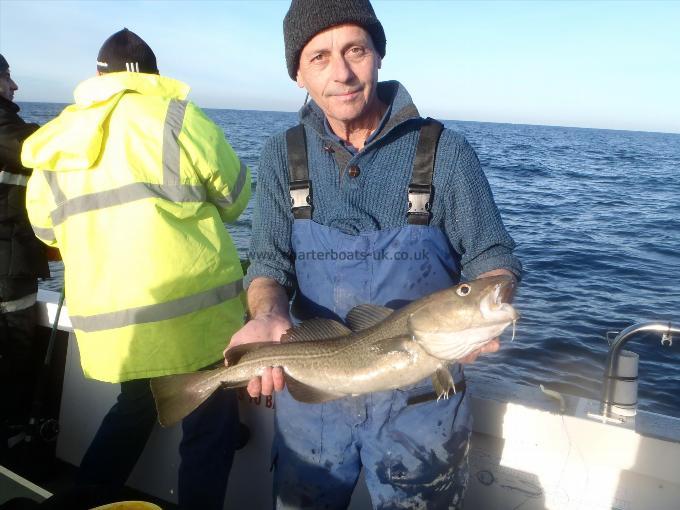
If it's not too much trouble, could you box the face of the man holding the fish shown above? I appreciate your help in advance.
[297,25,381,126]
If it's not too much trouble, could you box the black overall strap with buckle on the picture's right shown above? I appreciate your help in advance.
[406,117,444,225]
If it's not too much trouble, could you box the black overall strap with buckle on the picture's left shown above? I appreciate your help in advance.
[286,124,312,220]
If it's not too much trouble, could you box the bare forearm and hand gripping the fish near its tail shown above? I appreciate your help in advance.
[224,278,292,397]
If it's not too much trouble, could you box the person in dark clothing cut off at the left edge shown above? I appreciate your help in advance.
[0,55,49,460]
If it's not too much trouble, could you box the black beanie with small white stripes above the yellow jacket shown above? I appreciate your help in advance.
[97,28,158,74]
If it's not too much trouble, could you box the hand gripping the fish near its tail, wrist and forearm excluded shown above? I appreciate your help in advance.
[224,314,292,397]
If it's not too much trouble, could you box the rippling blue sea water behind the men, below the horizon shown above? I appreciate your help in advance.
[21,103,680,416]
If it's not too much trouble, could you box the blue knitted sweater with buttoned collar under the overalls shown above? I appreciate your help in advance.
[245,81,522,292]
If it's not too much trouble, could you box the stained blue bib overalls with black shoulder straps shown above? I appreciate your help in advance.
[272,121,471,509]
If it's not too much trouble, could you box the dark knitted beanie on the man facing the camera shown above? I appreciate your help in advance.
[283,0,387,80]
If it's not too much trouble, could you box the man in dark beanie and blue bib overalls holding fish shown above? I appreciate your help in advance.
[225,0,521,508]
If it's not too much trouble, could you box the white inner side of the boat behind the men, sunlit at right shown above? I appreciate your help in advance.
[6,292,680,510]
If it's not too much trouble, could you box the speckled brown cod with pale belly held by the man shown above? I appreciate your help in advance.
[151,276,519,426]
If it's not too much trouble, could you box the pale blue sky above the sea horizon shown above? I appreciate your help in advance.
[0,0,680,133]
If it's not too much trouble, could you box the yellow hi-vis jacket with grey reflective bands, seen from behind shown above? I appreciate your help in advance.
[22,72,251,382]
